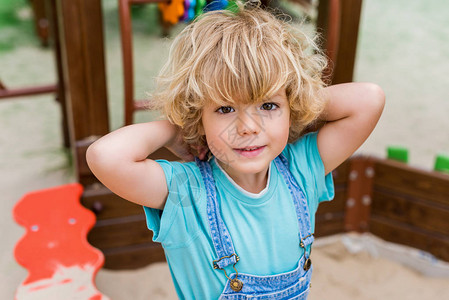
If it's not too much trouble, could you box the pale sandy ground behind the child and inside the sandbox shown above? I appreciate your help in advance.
[0,0,449,299]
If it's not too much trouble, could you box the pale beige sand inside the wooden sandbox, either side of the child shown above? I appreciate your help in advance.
[93,234,449,300]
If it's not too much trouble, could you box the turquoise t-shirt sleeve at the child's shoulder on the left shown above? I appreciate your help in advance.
[143,160,202,247]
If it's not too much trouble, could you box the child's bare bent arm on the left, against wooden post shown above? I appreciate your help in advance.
[86,121,189,209]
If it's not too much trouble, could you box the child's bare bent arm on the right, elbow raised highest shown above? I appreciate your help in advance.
[317,83,385,174]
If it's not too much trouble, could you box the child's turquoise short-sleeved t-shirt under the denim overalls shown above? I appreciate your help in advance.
[144,132,334,299]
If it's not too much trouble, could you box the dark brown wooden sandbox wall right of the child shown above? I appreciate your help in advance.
[316,156,449,261]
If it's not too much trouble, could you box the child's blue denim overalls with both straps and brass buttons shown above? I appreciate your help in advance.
[196,154,313,300]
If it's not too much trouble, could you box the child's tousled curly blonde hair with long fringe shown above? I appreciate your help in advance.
[151,2,327,148]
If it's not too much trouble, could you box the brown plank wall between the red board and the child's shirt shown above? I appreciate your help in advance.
[81,184,165,270]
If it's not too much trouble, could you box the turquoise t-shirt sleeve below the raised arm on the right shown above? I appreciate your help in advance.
[284,132,334,211]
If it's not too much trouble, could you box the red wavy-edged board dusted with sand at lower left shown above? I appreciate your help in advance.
[13,183,109,300]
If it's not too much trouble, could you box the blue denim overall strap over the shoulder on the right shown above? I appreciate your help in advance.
[274,154,314,251]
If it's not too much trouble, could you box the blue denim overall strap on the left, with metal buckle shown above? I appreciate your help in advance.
[195,158,239,269]
